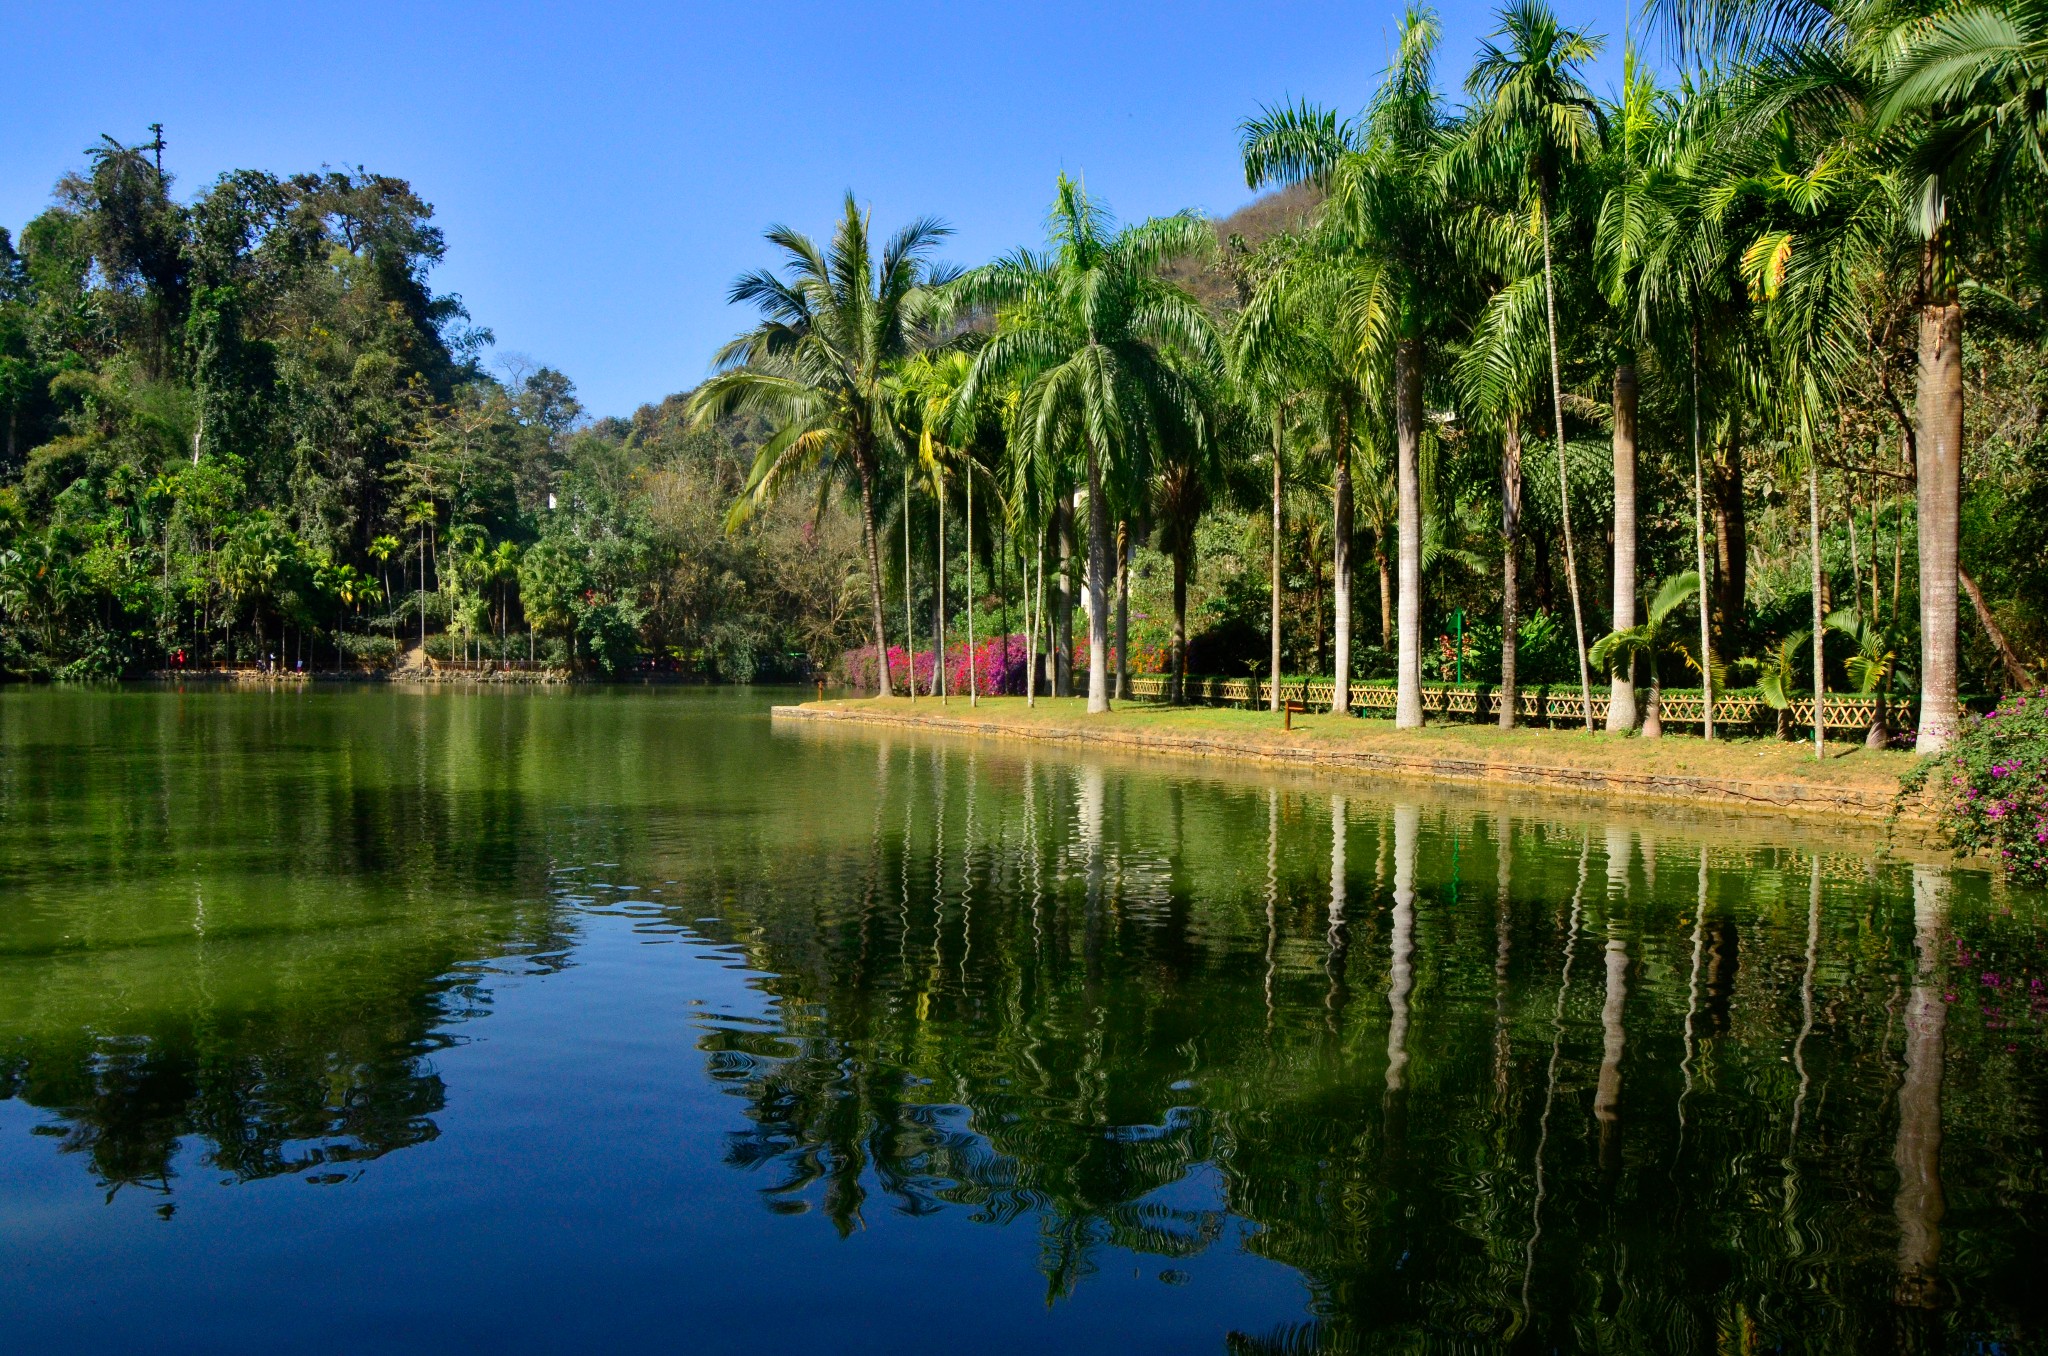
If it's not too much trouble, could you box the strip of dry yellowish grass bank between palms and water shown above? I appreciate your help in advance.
[770,698,1925,828]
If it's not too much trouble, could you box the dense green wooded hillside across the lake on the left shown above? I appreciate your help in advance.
[0,139,852,678]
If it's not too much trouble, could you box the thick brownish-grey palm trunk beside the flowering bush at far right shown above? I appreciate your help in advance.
[1915,294,1962,754]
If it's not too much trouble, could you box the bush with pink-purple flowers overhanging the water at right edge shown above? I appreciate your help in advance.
[1898,688,2048,885]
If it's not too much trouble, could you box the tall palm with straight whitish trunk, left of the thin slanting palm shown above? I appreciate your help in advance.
[1243,8,1454,727]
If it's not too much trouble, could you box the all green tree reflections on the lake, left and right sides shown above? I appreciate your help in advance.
[0,698,2048,1352]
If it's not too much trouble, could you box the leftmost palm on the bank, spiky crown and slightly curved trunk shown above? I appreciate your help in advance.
[690,193,948,696]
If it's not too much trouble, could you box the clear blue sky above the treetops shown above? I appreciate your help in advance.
[0,0,1626,414]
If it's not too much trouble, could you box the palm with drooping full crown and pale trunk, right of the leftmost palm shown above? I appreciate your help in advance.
[956,174,1221,713]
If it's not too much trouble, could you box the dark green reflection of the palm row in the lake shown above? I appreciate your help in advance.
[707,752,2042,1352]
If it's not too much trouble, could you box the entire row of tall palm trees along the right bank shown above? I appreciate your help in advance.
[694,0,2048,752]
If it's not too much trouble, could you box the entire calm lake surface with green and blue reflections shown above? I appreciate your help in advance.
[0,690,2048,1352]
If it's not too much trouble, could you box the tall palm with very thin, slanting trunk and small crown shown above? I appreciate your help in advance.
[1466,0,1602,729]
